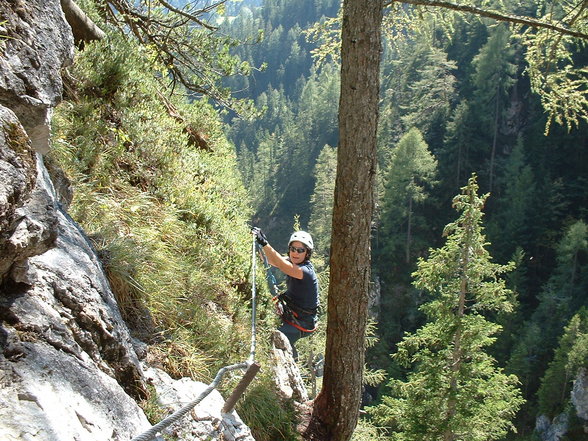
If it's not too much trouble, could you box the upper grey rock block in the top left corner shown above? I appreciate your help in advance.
[0,0,73,153]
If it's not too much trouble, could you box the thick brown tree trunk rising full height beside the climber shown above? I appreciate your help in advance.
[305,0,383,441]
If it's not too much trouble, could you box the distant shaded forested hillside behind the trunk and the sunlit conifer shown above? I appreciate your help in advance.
[222,0,588,440]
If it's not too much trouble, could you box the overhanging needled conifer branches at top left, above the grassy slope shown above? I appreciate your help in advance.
[84,0,256,116]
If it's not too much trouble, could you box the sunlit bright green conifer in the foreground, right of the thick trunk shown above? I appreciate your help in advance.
[374,176,523,441]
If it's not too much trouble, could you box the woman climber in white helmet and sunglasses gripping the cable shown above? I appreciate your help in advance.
[251,227,319,360]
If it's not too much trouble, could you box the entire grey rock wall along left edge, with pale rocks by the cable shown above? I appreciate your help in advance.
[0,0,252,441]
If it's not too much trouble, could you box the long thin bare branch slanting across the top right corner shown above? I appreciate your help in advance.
[384,0,588,40]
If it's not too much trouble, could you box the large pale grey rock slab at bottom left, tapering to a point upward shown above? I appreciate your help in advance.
[0,139,148,440]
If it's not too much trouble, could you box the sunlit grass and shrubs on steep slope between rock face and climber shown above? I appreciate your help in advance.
[52,29,263,380]
